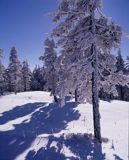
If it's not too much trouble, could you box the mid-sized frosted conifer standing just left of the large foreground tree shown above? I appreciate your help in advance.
[40,38,57,102]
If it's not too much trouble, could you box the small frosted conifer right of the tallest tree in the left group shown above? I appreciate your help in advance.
[22,61,32,91]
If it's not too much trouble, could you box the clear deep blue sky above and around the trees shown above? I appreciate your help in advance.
[0,0,129,68]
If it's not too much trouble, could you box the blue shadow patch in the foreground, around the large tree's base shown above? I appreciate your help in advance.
[26,135,105,160]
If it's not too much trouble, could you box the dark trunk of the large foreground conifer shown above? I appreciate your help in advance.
[91,11,102,143]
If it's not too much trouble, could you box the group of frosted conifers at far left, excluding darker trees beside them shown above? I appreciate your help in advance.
[0,47,31,94]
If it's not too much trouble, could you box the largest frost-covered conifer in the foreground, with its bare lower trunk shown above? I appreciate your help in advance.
[53,0,127,142]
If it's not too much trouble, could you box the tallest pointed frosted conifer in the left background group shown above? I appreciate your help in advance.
[7,47,23,94]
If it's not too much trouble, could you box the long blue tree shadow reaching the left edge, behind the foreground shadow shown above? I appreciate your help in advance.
[0,102,80,160]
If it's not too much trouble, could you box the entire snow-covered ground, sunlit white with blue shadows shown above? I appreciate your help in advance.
[0,92,129,160]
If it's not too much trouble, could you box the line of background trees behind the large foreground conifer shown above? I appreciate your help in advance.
[0,42,129,101]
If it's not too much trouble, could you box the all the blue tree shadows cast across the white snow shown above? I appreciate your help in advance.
[0,102,121,160]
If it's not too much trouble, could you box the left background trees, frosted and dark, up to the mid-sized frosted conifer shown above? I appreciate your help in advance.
[0,47,45,95]
